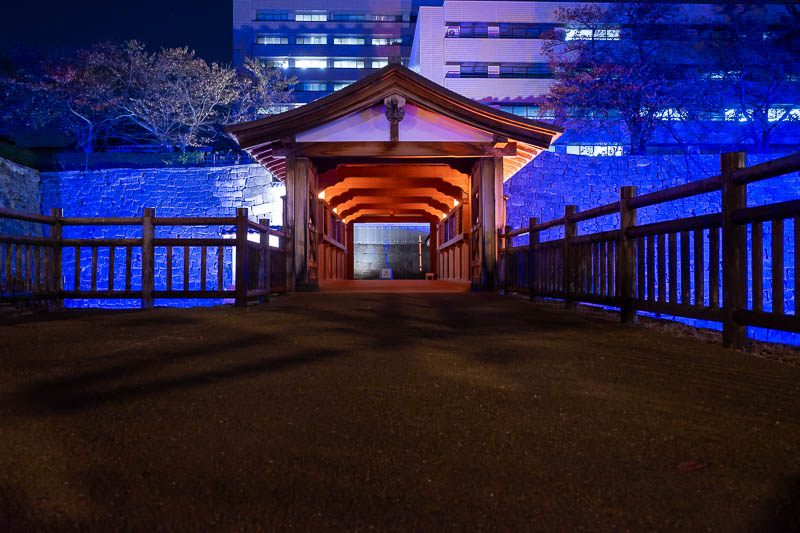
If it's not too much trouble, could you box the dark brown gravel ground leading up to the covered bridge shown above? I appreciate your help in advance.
[0,293,800,532]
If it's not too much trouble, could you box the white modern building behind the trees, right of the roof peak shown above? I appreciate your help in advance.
[409,0,800,156]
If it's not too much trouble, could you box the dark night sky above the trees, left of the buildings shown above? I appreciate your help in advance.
[0,0,232,63]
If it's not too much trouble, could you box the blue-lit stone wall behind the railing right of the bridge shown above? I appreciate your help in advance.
[504,152,800,345]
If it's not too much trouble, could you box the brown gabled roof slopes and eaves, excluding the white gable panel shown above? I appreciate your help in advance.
[225,64,564,182]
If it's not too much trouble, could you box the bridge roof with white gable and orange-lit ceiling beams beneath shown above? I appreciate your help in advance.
[226,64,563,221]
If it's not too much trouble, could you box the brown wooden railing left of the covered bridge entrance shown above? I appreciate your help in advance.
[0,208,290,309]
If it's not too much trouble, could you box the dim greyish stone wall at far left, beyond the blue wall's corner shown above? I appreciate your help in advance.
[0,157,42,235]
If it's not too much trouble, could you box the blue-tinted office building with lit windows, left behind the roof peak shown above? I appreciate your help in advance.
[233,0,440,104]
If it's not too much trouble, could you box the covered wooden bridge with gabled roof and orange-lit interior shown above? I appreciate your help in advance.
[227,64,563,290]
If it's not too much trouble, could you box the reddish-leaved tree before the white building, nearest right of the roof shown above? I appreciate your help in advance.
[544,2,703,154]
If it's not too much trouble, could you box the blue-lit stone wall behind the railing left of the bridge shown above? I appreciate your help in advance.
[41,165,285,307]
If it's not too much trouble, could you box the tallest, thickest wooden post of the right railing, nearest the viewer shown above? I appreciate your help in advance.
[720,152,752,349]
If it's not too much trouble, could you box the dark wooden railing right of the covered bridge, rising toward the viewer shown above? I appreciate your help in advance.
[500,153,800,348]
